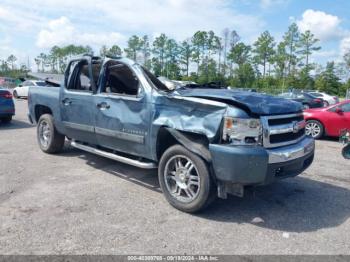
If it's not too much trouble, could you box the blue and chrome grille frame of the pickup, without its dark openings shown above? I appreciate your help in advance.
[260,113,305,148]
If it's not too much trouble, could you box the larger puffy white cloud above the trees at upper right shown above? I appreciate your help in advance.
[297,9,344,41]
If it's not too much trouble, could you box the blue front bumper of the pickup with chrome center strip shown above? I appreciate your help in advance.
[209,137,315,185]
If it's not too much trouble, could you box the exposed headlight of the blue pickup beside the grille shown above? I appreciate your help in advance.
[222,117,262,145]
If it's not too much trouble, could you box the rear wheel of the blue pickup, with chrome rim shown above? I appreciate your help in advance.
[37,114,65,154]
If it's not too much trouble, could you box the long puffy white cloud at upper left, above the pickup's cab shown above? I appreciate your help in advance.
[36,16,125,48]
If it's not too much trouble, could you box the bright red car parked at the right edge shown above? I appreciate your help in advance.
[304,100,350,139]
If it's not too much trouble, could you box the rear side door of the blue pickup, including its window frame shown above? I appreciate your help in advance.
[60,57,98,144]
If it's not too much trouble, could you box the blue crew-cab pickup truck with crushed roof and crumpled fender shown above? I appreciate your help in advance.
[28,55,314,212]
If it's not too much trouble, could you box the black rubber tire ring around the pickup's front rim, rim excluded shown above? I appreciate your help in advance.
[158,145,212,213]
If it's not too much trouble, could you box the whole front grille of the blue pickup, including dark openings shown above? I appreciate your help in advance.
[261,113,305,148]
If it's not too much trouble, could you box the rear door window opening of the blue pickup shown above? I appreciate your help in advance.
[67,60,92,92]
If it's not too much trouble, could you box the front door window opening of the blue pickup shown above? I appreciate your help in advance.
[102,61,140,96]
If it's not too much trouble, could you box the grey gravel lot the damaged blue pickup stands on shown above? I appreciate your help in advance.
[0,100,350,254]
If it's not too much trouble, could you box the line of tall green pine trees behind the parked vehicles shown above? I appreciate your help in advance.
[0,23,350,96]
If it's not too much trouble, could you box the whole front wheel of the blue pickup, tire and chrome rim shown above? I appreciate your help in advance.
[158,145,215,213]
